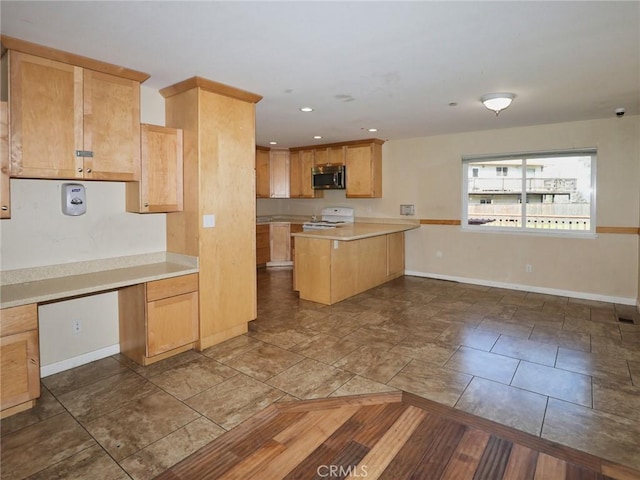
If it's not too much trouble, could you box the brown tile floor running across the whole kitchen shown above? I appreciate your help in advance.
[0,269,640,480]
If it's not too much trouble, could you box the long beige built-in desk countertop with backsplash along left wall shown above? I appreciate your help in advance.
[0,252,198,308]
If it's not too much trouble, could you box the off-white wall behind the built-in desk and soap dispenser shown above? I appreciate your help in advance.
[0,86,166,373]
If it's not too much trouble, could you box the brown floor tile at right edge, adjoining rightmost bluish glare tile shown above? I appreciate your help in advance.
[593,378,640,422]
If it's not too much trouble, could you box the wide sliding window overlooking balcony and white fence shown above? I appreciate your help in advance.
[462,149,596,234]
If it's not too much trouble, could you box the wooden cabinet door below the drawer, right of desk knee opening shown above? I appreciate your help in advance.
[147,292,198,357]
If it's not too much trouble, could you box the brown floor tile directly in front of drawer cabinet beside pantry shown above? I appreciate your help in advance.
[149,357,238,400]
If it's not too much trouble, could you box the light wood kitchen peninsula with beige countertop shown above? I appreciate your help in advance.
[292,223,419,305]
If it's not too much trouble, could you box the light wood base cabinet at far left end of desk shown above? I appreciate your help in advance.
[0,304,40,418]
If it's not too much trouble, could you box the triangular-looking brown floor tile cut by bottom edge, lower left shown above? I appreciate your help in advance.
[26,445,130,480]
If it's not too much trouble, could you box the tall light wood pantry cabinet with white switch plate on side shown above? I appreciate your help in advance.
[160,77,262,350]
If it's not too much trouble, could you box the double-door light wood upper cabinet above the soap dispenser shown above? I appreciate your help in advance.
[3,50,140,181]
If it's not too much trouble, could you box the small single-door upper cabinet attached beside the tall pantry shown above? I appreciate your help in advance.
[126,124,183,213]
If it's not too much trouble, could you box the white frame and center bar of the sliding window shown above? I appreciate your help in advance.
[461,147,598,238]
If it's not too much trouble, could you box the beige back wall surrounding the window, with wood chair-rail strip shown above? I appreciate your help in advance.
[258,116,640,303]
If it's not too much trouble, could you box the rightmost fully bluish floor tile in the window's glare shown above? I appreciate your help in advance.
[511,362,592,407]
